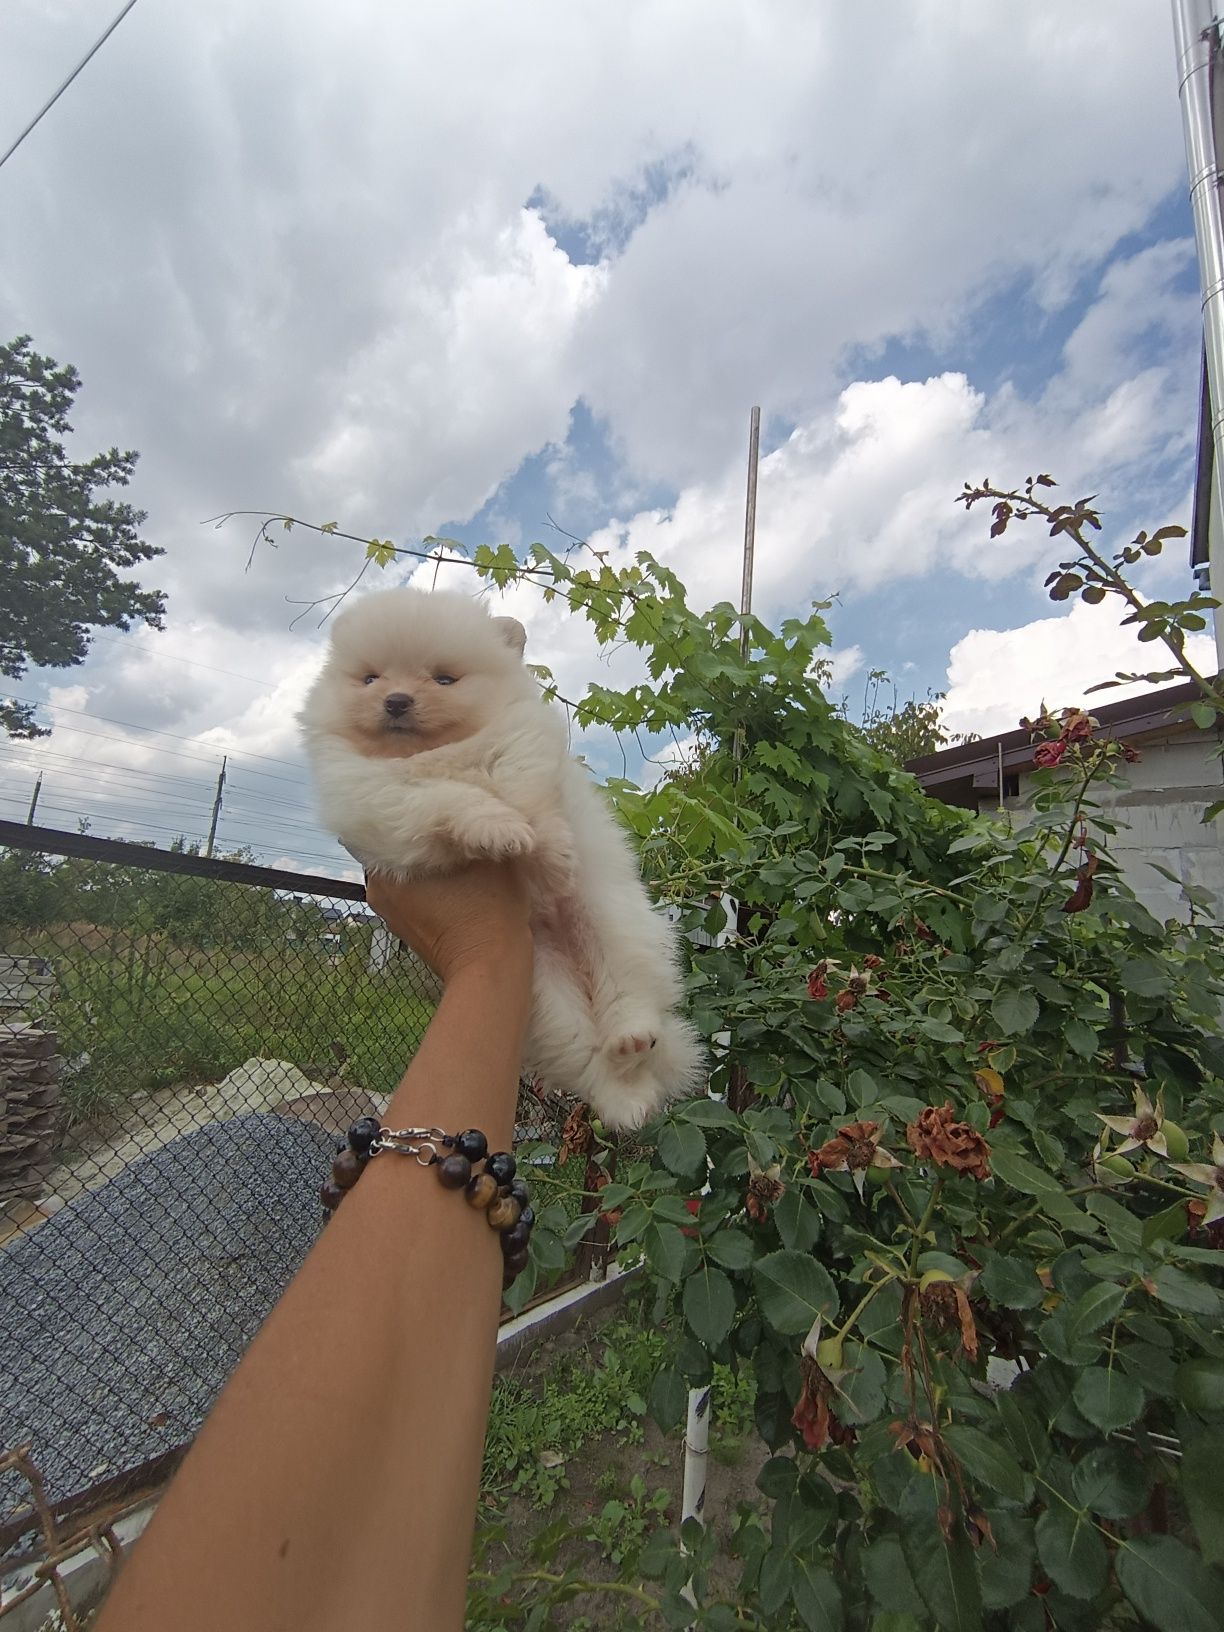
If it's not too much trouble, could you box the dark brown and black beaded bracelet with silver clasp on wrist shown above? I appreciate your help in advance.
[320,1116,535,1289]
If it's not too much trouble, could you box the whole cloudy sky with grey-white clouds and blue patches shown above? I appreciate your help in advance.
[0,0,1200,871]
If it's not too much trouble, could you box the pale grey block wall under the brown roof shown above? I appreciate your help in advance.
[1009,731,1224,920]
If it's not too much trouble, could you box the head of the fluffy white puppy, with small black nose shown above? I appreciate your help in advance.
[307,591,526,757]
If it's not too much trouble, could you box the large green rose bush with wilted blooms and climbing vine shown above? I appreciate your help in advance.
[256,478,1224,1632]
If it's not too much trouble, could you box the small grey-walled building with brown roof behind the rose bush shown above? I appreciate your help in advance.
[906,684,1224,920]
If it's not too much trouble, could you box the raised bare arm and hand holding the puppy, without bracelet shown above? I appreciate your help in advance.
[98,863,530,1632]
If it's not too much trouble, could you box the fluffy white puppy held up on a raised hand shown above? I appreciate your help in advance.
[300,589,702,1128]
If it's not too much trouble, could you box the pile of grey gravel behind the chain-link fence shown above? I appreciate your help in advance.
[0,1115,331,1519]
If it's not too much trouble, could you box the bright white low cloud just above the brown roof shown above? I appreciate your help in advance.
[945,601,1216,736]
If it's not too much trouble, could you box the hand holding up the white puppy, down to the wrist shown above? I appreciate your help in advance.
[366,862,532,984]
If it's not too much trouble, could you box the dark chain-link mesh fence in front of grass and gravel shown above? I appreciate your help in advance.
[0,823,584,1554]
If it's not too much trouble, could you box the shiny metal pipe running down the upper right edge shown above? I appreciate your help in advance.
[1173,0,1224,667]
